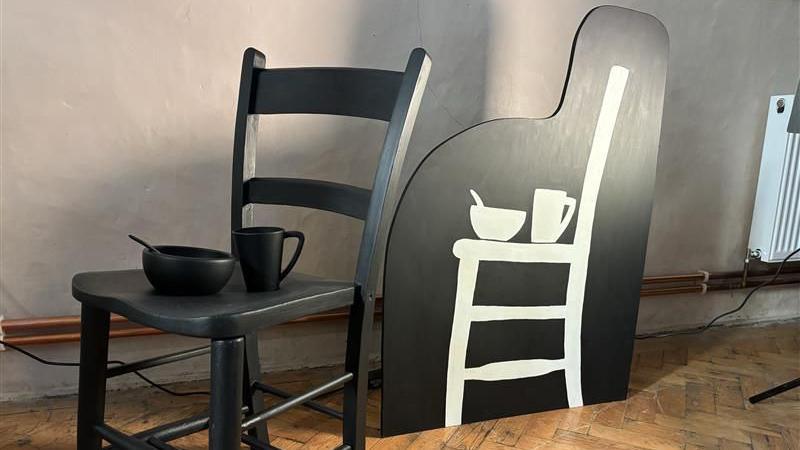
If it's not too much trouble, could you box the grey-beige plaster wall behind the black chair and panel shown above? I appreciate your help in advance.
[0,0,800,399]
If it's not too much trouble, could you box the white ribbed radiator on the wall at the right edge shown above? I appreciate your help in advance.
[748,95,800,263]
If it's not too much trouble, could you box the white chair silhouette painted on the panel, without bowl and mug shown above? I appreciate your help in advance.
[445,66,628,426]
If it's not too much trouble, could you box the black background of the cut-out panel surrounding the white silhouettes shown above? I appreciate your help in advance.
[382,7,668,435]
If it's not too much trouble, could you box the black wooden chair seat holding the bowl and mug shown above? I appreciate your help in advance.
[72,266,354,338]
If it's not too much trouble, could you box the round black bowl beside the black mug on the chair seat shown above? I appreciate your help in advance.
[142,245,236,295]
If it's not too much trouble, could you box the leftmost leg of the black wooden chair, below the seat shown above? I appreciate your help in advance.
[77,305,109,450]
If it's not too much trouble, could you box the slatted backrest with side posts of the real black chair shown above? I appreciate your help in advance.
[231,48,431,296]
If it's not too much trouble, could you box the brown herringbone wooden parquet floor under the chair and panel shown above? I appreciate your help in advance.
[0,322,800,450]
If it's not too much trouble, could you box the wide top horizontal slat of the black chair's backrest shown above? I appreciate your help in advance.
[250,68,403,122]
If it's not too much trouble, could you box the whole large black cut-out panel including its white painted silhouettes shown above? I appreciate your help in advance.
[382,7,668,435]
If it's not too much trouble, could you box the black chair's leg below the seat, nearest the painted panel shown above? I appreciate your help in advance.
[342,298,375,450]
